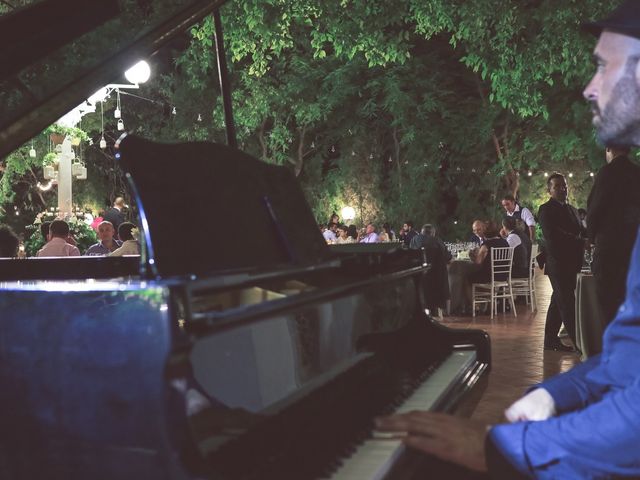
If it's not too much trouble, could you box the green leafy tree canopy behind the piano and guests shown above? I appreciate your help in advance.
[0,0,619,238]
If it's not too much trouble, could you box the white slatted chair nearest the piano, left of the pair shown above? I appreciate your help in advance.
[471,247,517,318]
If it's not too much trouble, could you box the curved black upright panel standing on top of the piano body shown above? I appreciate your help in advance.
[116,135,330,277]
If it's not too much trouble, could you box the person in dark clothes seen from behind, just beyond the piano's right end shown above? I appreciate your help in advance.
[409,223,451,314]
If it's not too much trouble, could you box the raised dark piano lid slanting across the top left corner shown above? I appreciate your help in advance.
[0,0,224,157]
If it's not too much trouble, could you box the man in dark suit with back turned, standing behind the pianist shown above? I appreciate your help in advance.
[587,147,640,325]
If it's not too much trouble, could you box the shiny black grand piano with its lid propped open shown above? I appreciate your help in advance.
[0,0,490,480]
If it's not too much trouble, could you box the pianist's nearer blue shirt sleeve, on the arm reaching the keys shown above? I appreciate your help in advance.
[489,377,640,478]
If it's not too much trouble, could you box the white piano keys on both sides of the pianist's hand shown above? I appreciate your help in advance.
[325,350,476,480]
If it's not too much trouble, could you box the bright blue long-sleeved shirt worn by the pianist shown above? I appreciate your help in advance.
[490,227,640,479]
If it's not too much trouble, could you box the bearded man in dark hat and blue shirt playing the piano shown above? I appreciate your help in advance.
[379,0,640,479]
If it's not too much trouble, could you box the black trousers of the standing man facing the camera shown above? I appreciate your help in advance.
[544,273,577,345]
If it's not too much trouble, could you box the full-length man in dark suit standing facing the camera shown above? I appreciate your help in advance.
[538,173,584,352]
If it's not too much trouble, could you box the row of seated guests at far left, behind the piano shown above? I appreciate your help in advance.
[0,219,140,258]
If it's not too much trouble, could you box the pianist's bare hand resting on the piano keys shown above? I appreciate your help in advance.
[376,411,488,472]
